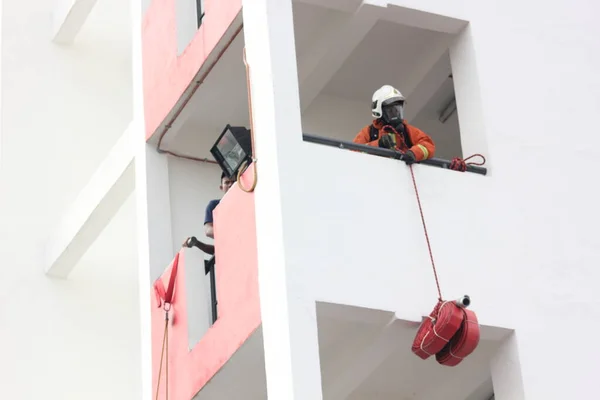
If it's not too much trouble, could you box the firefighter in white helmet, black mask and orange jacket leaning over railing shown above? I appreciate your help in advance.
[353,85,435,165]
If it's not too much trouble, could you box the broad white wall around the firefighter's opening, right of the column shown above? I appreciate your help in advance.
[286,0,600,400]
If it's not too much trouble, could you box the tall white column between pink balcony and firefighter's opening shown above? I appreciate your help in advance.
[243,0,323,400]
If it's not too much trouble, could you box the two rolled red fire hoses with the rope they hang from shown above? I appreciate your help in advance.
[410,165,479,366]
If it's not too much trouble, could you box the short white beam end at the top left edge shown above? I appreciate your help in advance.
[52,0,98,44]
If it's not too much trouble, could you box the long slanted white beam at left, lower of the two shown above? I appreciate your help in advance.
[44,125,135,278]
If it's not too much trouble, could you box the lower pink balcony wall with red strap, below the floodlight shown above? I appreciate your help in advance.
[152,165,261,400]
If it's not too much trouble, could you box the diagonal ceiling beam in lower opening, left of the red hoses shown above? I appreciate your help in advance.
[323,319,406,400]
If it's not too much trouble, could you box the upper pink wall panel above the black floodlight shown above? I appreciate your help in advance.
[142,0,242,139]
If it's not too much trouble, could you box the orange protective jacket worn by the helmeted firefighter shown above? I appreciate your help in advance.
[353,120,435,161]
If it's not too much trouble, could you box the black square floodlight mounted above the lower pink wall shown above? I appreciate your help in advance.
[210,124,252,179]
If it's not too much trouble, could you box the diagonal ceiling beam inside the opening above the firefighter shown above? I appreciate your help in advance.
[298,6,378,112]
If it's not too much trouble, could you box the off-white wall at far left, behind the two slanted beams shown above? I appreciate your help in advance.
[0,0,140,400]
